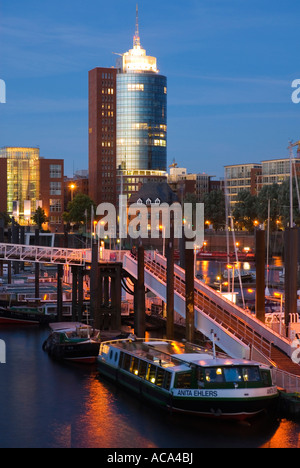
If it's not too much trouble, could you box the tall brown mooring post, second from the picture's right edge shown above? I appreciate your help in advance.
[255,229,266,323]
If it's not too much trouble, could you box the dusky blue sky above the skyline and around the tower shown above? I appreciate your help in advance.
[0,0,300,178]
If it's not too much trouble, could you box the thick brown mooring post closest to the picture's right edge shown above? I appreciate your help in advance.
[284,228,298,336]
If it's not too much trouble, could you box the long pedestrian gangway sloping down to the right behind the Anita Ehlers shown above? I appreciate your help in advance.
[123,252,292,359]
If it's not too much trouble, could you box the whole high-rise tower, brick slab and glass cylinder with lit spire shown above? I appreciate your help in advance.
[89,5,167,204]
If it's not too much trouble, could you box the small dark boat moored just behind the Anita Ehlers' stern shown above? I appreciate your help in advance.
[43,322,100,364]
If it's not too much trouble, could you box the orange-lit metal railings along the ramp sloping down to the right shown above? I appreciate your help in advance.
[123,252,291,358]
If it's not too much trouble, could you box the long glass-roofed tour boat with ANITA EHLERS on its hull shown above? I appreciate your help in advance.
[98,337,279,419]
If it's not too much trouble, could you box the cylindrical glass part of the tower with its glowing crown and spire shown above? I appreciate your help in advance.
[116,8,167,197]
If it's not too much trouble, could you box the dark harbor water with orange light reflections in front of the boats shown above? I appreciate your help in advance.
[0,327,300,449]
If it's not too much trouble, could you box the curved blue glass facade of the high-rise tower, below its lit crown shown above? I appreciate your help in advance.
[117,72,167,174]
